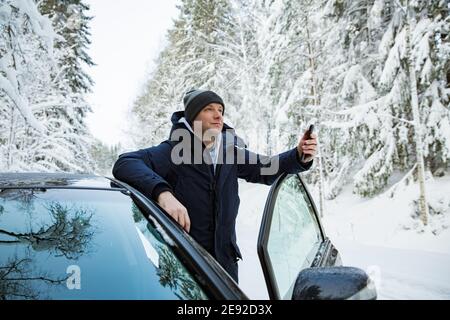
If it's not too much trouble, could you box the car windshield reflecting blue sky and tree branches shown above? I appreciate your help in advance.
[0,189,207,299]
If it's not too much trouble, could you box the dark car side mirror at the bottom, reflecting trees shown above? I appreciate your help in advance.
[292,267,377,300]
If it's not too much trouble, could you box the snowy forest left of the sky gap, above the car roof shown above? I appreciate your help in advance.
[0,0,117,173]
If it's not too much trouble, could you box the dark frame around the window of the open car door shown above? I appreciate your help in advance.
[257,173,341,300]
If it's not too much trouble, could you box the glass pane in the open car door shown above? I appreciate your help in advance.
[267,175,323,299]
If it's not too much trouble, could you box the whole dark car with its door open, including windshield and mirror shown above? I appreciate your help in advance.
[0,173,376,300]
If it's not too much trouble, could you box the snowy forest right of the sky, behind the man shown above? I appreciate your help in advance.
[130,0,450,224]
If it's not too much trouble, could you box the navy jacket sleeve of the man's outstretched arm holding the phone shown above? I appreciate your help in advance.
[237,148,313,185]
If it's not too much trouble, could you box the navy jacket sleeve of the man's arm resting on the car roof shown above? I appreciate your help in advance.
[112,143,173,200]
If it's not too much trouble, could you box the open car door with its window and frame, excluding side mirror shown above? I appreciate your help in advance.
[258,174,341,299]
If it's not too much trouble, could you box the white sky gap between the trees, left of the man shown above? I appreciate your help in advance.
[86,0,178,145]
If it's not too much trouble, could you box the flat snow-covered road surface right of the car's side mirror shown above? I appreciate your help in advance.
[333,239,450,299]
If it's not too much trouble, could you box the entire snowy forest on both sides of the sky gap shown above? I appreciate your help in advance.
[0,0,450,224]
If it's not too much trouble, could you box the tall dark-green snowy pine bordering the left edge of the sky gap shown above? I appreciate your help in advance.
[39,0,94,170]
